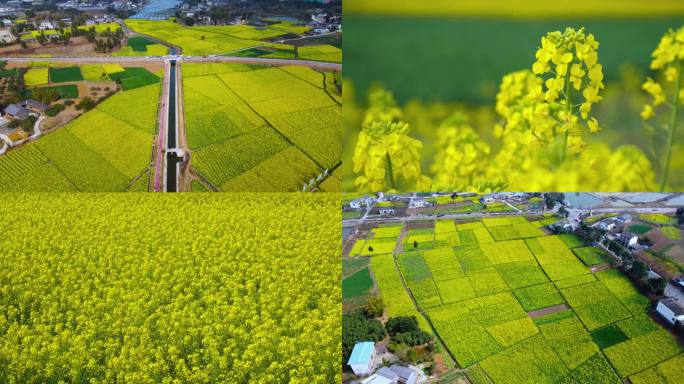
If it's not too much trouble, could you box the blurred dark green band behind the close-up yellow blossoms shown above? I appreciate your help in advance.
[343,14,684,104]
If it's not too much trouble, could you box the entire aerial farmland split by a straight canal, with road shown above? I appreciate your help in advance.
[0,7,342,192]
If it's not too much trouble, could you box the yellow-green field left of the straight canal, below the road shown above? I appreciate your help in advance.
[0,85,160,192]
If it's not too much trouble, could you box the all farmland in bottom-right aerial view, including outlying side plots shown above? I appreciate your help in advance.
[342,194,684,384]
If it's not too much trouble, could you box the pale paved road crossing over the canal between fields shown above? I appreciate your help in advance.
[0,56,342,71]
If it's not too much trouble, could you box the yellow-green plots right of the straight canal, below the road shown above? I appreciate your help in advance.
[183,63,342,191]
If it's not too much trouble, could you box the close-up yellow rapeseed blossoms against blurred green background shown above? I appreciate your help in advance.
[352,27,684,192]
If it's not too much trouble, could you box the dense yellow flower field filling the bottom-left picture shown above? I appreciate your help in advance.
[0,193,342,383]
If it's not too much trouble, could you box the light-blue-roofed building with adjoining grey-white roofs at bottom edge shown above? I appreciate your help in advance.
[347,341,427,384]
